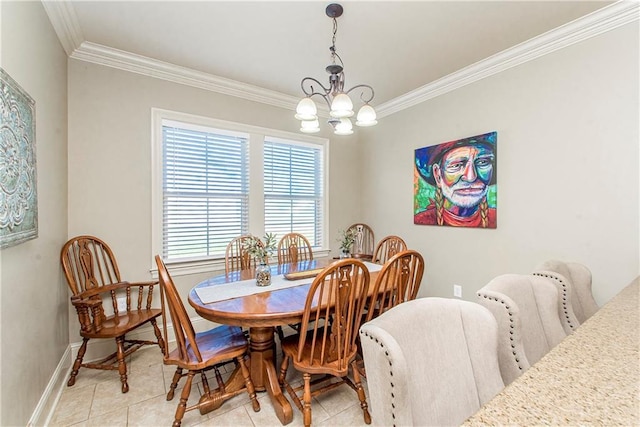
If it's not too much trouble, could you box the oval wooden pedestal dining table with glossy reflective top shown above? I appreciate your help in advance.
[189,258,334,425]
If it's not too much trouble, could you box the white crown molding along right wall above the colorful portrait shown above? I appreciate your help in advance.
[376,1,640,118]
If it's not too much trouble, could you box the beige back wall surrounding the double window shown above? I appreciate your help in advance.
[69,60,361,342]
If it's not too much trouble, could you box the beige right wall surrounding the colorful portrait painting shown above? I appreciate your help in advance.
[363,22,640,304]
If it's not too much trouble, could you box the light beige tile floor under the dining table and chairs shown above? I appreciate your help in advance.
[49,346,371,427]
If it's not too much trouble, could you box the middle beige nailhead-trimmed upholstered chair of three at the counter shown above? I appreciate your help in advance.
[477,274,567,384]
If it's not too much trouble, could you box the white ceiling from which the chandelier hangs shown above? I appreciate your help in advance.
[45,0,611,112]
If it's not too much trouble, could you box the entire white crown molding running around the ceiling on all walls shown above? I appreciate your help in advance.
[42,0,640,118]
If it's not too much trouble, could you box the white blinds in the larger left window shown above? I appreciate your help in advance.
[162,121,249,261]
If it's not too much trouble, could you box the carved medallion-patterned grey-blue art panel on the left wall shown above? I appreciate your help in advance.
[0,68,38,248]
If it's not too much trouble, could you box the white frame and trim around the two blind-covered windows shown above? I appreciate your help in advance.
[150,108,330,277]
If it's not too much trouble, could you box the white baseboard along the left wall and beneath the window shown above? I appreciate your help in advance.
[27,317,211,427]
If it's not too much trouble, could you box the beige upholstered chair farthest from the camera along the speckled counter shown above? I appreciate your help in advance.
[534,260,599,323]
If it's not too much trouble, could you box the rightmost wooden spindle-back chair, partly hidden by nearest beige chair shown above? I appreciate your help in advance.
[365,249,424,322]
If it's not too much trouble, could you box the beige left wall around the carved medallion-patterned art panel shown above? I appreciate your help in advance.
[0,1,69,426]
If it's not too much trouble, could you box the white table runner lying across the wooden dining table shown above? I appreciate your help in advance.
[195,262,382,304]
